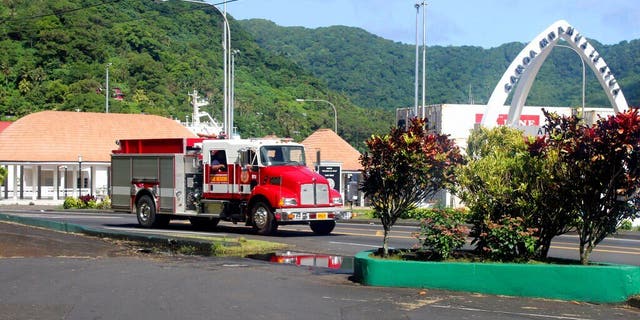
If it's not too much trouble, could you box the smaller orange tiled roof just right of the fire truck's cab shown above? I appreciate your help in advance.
[301,129,362,171]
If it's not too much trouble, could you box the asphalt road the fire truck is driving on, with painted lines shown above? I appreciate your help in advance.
[5,207,640,265]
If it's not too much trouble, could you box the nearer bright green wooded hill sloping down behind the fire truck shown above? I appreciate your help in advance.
[0,0,393,149]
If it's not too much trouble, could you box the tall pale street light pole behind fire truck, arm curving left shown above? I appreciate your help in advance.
[162,0,233,138]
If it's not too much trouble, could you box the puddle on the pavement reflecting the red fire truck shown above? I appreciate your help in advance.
[249,251,353,273]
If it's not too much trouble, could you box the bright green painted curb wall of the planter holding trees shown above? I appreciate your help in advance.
[354,251,640,303]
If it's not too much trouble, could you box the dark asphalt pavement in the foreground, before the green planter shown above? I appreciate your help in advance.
[0,223,640,320]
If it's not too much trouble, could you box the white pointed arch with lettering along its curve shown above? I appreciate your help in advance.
[481,20,629,127]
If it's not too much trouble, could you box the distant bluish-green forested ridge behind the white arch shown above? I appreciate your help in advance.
[240,19,640,109]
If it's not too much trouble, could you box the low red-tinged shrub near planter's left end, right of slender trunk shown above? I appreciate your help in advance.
[416,208,469,260]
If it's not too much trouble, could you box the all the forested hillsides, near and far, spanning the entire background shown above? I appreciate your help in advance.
[0,0,640,150]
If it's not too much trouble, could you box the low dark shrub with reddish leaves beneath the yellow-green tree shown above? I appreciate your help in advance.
[474,216,536,261]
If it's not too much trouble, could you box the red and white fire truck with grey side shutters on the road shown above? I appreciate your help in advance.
[111,138,350,235]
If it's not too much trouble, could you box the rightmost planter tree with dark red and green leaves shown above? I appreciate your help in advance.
[530,110,640,264]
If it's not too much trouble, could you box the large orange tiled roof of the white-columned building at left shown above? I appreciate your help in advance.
[0,111,195,162]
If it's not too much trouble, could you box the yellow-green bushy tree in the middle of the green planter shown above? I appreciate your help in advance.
[458,126,574,260]
